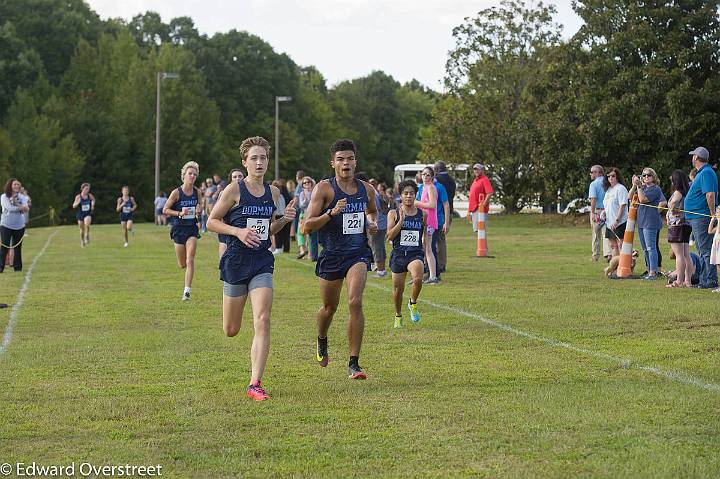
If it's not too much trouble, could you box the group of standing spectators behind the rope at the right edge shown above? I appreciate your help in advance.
[588,146,720,292]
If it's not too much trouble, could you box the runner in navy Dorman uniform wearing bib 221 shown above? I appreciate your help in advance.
[304,140,377,379]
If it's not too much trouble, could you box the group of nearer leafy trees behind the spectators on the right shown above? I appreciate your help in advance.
[422,0,720,211]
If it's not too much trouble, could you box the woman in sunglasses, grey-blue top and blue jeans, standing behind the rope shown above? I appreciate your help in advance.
[628,168,667,280]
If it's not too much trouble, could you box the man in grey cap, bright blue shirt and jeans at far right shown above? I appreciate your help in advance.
[683,146,718,289]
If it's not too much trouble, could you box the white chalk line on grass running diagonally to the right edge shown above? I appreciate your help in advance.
[284,258,720,392]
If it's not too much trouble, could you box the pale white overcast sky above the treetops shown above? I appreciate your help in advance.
[86,0,582,90]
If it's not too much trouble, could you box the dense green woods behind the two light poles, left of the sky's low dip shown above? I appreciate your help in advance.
[0,0,437,221]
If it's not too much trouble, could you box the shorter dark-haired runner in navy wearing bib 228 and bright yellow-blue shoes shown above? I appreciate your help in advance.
[387,180,427,328]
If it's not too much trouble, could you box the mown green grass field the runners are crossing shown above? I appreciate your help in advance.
[0,216,720,478]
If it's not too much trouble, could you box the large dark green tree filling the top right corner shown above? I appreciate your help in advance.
[574,0,720,182]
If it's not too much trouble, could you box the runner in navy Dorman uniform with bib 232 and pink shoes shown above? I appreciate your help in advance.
[207,136,296,401]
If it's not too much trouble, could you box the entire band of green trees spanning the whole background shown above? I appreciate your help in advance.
[0,0,720,221]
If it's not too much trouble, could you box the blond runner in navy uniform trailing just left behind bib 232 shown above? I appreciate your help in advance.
[163,161,203,301]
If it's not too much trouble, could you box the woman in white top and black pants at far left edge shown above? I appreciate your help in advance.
[0,178,30,273]
